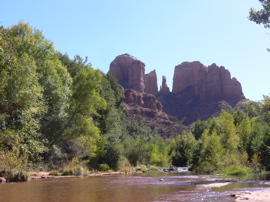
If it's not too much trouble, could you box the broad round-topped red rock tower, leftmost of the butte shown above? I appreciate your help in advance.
[108,54,145,92]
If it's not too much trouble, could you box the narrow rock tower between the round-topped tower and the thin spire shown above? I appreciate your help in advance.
[144,70,158,95]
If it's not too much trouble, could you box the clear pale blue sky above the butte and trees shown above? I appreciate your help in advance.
[0,0,270,101]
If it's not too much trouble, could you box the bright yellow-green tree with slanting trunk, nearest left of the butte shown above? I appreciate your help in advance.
[51,67,106,146]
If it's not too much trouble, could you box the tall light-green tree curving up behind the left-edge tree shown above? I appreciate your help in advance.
[5,22,72,150]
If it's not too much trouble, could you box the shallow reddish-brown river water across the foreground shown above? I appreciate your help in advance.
[0,173,270,202]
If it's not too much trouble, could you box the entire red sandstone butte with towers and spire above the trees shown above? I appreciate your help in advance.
[108,54,245,124]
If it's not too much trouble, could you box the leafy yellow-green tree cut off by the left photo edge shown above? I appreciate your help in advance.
[0,25,45,160]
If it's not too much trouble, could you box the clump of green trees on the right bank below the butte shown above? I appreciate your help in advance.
[170,105,270,173]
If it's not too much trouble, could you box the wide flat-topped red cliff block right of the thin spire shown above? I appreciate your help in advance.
[172,62,245,103]
